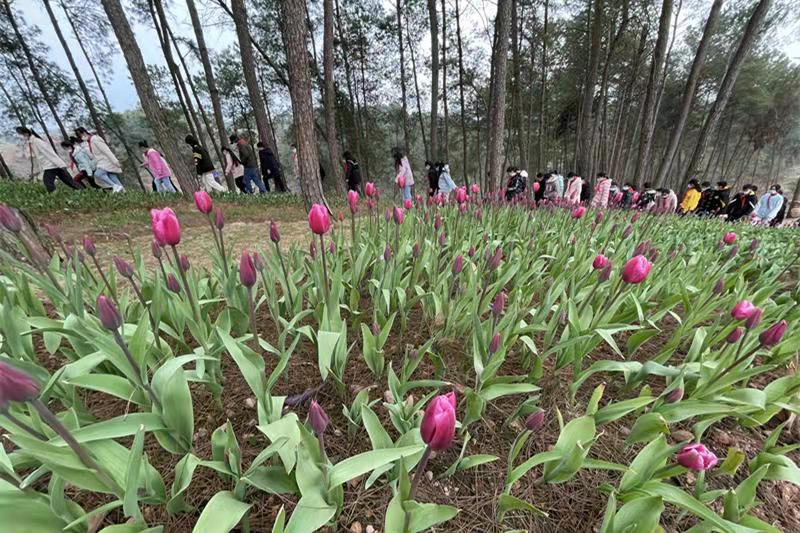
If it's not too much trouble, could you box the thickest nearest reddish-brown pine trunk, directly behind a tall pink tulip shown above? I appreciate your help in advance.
[282,0,327,207]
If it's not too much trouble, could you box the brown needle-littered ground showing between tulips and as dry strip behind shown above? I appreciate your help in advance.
[10,193,800,533]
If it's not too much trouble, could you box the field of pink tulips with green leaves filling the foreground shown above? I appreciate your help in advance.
[0,188,800,533]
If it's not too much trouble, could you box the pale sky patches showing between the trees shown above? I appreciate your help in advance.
[10,0,800,111]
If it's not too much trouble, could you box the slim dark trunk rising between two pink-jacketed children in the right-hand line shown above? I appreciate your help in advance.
[576,0,603,179]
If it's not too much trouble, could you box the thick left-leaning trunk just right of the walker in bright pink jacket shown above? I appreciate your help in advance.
[102,0,197,195]
